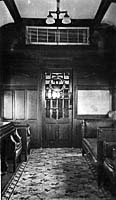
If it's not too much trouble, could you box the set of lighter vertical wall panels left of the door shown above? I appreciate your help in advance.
[3,89,37,120]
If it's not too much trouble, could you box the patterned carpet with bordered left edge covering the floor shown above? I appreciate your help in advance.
[2,148,112,200]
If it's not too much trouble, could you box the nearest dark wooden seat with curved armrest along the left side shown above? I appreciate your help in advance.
[0,122,22,172]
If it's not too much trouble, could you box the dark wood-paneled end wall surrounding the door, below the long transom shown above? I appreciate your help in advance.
[1,22,116,147]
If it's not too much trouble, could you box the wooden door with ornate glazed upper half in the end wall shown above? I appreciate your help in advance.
[42,72,72,147]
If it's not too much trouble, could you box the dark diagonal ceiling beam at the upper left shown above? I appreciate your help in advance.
[3,0,21,22]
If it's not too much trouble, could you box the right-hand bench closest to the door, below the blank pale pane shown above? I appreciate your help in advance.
[82,119,114,185]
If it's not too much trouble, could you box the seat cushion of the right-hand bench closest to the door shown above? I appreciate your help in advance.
[82,138,97,163]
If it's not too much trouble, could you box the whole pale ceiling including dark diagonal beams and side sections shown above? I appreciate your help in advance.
[0,0,116,26]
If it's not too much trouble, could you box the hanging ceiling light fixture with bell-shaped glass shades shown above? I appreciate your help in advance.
[46,0,71,24]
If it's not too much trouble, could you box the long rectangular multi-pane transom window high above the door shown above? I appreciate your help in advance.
[26,26,89,45]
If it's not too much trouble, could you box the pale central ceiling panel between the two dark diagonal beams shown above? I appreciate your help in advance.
[15,0,101,19]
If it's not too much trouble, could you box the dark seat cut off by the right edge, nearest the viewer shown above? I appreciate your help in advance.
[98,127,116,194]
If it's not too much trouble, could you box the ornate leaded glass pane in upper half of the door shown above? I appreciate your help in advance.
[45,72,72,120]
